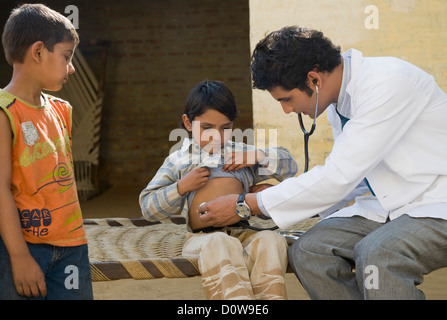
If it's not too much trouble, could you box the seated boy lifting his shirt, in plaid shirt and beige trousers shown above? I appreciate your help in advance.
[140,81,297,299]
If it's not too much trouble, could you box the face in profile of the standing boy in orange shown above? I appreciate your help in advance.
[39,41,76,91]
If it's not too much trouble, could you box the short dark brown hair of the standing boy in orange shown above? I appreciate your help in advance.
[2,4,79,65]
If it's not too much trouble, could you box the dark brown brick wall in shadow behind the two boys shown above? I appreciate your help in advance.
[0,0,252,186]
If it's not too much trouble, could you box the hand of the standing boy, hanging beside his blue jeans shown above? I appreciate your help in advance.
[11,256,47,297]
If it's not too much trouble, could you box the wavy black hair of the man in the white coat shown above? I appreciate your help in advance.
[250,26,341,96]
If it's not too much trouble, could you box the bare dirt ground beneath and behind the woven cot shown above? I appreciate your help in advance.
[81,186,447,300]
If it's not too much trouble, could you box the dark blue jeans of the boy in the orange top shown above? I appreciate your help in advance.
[0,238,93,300]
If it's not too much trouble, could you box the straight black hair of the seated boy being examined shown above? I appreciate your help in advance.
[183,80,238,122]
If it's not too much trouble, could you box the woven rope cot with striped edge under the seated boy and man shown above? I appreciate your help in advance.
[84,217,319,281]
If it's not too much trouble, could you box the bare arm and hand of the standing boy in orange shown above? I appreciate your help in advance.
[0,109,46,297]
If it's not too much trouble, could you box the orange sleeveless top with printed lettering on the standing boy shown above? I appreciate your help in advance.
[0,89,87,246]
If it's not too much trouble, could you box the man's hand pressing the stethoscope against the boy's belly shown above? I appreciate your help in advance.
[197,194,241,227]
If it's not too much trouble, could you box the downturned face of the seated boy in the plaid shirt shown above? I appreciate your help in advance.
[183,109,233,153]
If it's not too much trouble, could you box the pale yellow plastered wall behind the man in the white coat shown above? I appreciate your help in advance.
[249,0,447,173]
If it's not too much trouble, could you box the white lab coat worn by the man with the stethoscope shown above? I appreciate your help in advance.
[258,49,447,227]
